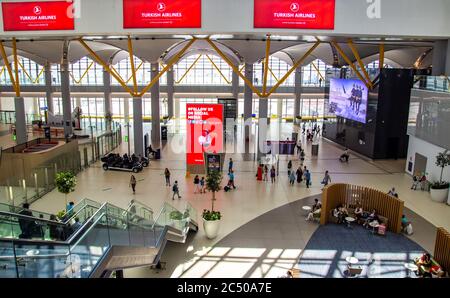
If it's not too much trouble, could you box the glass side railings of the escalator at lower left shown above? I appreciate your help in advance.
[0,199,196,278]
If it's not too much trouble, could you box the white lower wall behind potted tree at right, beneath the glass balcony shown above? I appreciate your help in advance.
[405,135,450,181]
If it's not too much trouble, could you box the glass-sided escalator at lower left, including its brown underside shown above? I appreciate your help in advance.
[0,200,198,278]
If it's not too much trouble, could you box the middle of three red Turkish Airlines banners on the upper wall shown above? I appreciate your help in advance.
[123,0,202,29]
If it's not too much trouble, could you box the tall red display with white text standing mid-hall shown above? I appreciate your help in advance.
[186,103,223,165]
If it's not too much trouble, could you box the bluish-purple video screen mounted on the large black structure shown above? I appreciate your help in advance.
[329,79,369,123]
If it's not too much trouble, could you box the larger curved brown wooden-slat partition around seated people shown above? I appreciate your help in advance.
[320,184,404,233]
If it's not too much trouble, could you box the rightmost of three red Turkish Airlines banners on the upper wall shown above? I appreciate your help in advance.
[253,0,335,29]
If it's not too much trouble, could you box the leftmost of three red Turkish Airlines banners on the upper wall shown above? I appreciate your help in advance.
[2,1,75,31]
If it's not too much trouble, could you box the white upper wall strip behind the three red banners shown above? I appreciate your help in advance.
[0,0,450,38]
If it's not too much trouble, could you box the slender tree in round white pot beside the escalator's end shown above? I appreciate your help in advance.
[202,171,222,239]
